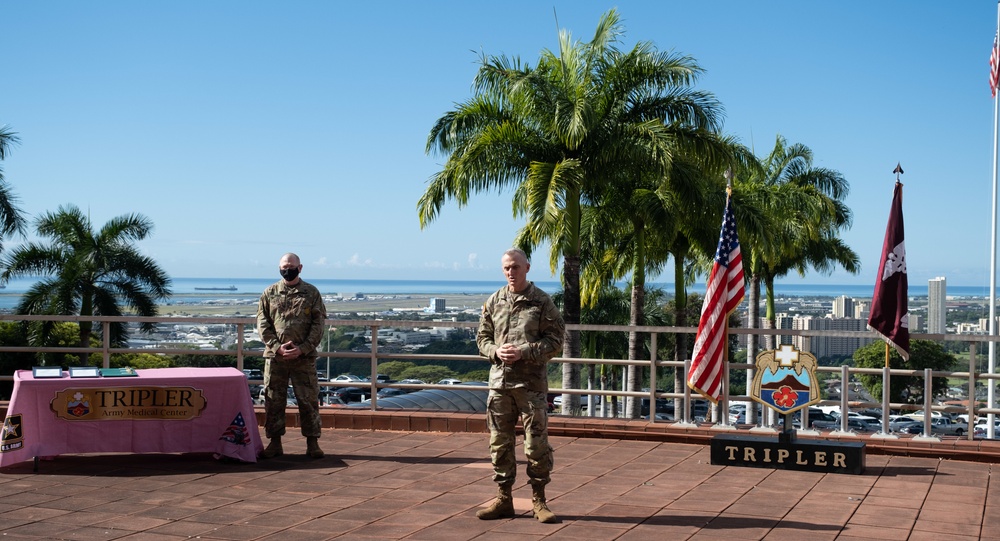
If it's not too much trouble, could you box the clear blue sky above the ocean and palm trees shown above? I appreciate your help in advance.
[0,0,997,286]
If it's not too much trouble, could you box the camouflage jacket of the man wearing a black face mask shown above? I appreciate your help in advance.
[257,280,326,358]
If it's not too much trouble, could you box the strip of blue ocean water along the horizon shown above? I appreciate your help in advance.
[0,277,989,310]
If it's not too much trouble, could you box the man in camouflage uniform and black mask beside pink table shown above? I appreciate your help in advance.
[257,253,326,458]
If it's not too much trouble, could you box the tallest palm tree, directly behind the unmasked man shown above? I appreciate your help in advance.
[417,10,721,411]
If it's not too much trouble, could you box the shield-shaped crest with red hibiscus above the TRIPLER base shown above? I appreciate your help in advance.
[750,345,821,415]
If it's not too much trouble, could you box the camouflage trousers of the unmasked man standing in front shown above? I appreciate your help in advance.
[486,388,553,486]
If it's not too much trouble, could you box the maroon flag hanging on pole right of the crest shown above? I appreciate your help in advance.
[868,181,910,359]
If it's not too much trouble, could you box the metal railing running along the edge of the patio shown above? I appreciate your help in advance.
[0,314,1000,439]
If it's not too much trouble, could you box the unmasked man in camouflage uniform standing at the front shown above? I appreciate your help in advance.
[476,249,565,522]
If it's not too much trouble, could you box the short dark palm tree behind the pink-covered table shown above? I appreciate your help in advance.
[0,205,170,364]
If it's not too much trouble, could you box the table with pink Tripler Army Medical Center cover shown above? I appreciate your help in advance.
[0,368,264,467]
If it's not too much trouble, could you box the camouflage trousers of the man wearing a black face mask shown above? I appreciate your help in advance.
[264,357,322,439]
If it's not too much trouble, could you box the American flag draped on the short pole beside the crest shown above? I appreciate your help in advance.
[688,193,744,402]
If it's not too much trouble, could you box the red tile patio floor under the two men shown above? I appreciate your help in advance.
[0,428,1000,541]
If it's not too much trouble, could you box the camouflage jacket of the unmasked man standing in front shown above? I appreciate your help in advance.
[476,283,565,393]
